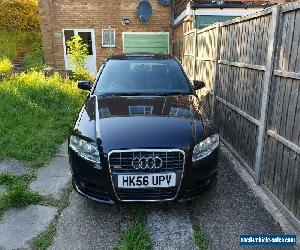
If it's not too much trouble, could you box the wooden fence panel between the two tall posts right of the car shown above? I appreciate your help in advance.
[215,12,272,172]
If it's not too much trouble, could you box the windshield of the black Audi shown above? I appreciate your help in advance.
[95,59,192,95]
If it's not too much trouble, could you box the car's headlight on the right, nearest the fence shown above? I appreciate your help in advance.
[192,134,220,161]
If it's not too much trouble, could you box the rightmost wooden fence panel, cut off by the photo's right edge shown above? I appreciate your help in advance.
[262,8,300,219]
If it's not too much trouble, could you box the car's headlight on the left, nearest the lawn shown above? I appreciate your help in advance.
[70,135,100,164]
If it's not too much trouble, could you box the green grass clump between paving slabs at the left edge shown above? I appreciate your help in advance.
[0,173,42,215]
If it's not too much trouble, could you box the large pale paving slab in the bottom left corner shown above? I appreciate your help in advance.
[0,205,57,249]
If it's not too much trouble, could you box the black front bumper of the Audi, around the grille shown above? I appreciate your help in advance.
[69,149,219,204]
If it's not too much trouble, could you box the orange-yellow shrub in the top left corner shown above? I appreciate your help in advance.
[0,0,40,31]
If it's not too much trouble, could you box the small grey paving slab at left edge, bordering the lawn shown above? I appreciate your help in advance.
[0,159,30,176]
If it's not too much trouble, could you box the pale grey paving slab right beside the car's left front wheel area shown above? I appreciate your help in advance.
[30,156,71,199]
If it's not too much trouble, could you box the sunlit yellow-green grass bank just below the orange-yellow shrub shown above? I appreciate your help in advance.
[0,29,32,60]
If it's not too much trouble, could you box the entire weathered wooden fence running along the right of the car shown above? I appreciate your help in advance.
[182,2,300,219]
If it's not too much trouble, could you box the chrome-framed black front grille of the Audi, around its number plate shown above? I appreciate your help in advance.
[108,149,185,201]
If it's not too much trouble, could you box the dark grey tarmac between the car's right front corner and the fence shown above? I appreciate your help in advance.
[190,149,285,250]
